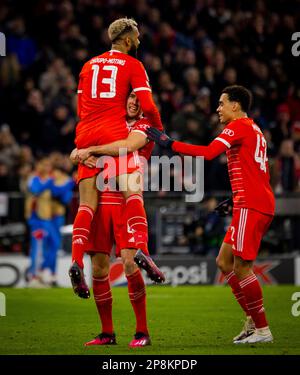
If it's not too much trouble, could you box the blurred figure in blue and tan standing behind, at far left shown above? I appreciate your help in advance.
[25,154,74,287]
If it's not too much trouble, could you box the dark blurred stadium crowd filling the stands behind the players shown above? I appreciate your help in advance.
[0,0,300,256]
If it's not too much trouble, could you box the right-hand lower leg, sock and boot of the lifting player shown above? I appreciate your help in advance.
[121,249,151,347]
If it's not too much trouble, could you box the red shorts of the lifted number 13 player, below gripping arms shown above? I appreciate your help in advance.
[77,152,141,183]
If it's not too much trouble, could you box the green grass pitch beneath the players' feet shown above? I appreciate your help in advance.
[0,286,300,355]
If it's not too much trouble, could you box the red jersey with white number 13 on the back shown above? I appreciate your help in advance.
[76,50,151,144]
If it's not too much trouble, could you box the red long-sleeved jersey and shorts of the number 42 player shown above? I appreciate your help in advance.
[172,118,275,260]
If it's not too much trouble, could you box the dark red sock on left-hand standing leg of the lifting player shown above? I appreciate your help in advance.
[93,275,114,334]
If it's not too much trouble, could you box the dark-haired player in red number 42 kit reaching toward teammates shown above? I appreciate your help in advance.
[147,85,275,344]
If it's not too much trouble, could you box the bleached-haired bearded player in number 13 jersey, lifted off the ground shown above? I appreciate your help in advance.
[69,18,162,298]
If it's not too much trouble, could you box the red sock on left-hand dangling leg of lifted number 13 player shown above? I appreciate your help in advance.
[72,204,94,268]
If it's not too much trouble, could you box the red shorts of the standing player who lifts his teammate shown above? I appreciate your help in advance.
[87,193,148,257]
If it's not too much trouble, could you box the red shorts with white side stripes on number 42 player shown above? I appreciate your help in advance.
[224,208,273,260]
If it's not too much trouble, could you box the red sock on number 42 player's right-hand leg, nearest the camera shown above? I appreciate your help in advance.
[240,274,268,328]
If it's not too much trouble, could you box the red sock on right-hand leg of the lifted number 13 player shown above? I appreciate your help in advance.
[125,194,149,255]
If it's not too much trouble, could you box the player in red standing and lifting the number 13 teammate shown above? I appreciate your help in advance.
[71,92,159,347]
